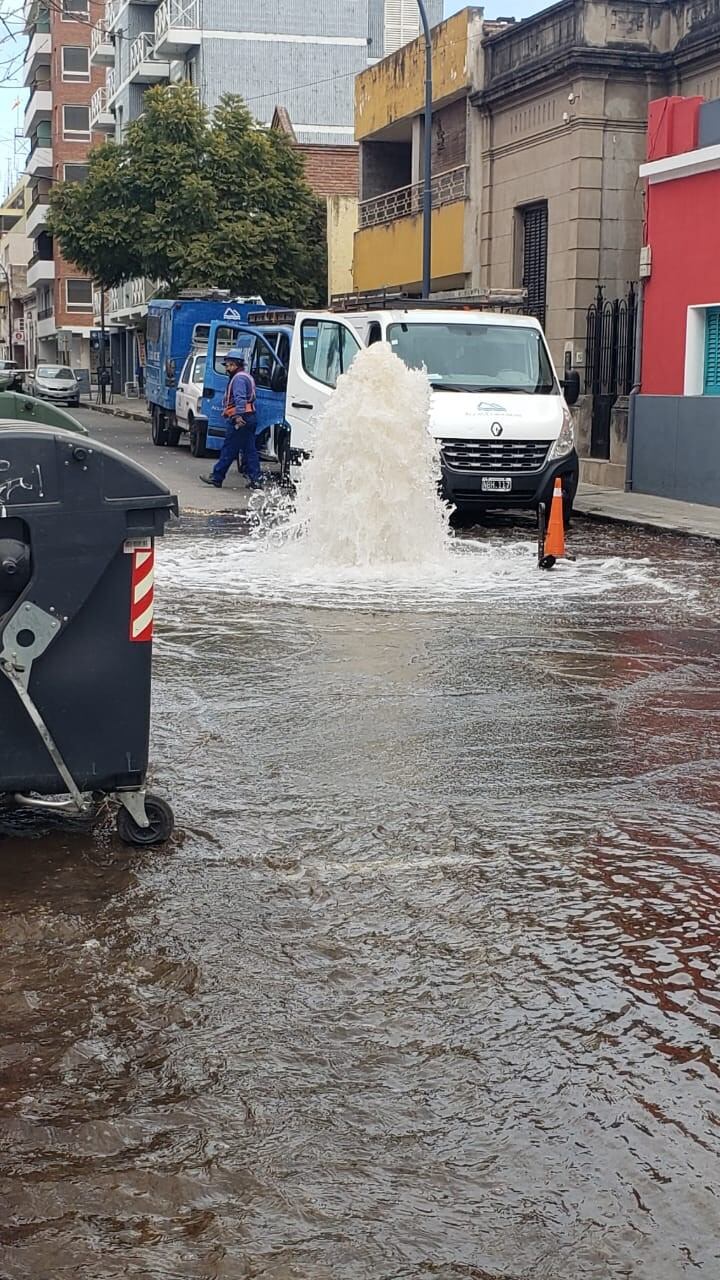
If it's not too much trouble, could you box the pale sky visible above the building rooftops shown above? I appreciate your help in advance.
[0,0,540,195]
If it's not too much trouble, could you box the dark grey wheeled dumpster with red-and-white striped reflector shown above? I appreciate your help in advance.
[0,422,178,845]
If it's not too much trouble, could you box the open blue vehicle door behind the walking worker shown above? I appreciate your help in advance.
[202,321,284,449]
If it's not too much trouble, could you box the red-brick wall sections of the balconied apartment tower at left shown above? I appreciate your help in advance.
[50,0,105,329]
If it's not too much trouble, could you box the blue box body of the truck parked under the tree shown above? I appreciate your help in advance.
[145,298,272,412]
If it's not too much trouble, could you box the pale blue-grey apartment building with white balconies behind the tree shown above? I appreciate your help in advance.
[91,0,442,383]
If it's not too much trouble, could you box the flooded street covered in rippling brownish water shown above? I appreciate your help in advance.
[0,516,720,1280]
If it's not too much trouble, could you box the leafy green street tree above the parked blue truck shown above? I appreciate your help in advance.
[50,86,325,306]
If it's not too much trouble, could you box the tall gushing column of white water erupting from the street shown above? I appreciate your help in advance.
[289,343,450,567]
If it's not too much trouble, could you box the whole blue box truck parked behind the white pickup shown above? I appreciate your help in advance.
[145,296,263,445]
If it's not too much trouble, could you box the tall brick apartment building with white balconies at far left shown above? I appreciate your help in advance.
[24,0,102,369]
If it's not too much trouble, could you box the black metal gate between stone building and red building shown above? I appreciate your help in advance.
[585,284,637,458]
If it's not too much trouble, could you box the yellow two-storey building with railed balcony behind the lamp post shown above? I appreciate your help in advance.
[352,8,489,292]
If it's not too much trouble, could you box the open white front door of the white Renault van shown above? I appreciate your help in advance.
[286,311,361,452]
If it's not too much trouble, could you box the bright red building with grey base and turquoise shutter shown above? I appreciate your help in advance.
[629,97,720,506]
